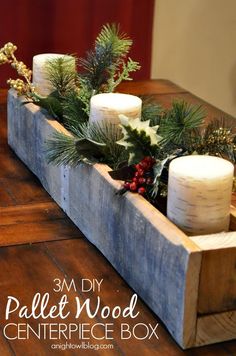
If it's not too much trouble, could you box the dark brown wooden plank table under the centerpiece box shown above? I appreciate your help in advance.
[0,80,236,356]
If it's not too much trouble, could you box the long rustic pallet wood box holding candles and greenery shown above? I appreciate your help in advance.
[8,90,236,348]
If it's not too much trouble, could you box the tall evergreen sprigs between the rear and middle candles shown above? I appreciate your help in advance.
[41,24,140,129]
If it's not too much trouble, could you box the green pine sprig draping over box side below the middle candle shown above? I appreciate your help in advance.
[47,123,127,168]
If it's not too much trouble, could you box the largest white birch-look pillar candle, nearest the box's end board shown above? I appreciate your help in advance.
[167,155,234,235]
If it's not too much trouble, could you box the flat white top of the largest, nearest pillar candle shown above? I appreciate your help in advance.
[170,155,234,180]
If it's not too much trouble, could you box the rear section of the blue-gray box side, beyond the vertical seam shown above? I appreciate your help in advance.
[8,90,64,206]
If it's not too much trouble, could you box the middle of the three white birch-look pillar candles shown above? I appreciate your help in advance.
[89,93,142,125]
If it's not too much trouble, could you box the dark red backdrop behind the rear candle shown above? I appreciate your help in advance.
[0,0,154,87]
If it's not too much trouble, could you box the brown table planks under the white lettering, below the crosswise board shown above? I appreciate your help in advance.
[0,239,228,356]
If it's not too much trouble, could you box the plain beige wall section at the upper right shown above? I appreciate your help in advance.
[151,0,236,117]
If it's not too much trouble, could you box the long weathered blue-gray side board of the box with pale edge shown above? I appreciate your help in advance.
[8,90,234,348]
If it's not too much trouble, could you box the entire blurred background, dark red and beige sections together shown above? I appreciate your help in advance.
[0,0,236,117]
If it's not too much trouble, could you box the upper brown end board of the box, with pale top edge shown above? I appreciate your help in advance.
[191,224,236,316]
